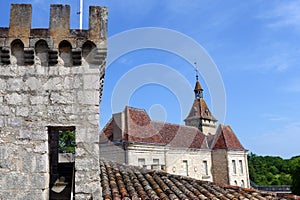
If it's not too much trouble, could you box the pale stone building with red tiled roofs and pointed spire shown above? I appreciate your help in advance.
[100,79,250,187]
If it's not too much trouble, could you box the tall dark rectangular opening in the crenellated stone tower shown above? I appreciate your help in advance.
[48,126,76,200]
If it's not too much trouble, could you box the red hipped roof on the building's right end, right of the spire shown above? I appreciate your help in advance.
[212,125,245,150]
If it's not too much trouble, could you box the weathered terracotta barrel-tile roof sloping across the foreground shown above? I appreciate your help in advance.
[100,161,282,200]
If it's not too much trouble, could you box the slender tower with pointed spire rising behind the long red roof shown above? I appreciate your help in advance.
[184,75,217,135]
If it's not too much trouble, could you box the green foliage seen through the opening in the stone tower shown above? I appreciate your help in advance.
[58,131,76,153]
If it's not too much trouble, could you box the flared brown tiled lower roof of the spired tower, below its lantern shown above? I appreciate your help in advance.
[184,98,217,121]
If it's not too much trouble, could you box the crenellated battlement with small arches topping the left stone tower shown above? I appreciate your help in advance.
[0,4,107,66]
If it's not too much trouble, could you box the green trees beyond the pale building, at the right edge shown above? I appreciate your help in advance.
[248,153,300,187]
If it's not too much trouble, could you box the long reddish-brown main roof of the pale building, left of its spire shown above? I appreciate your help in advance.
[100,106,208,148]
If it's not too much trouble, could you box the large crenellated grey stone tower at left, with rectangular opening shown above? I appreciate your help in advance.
[0,4,107,200]
